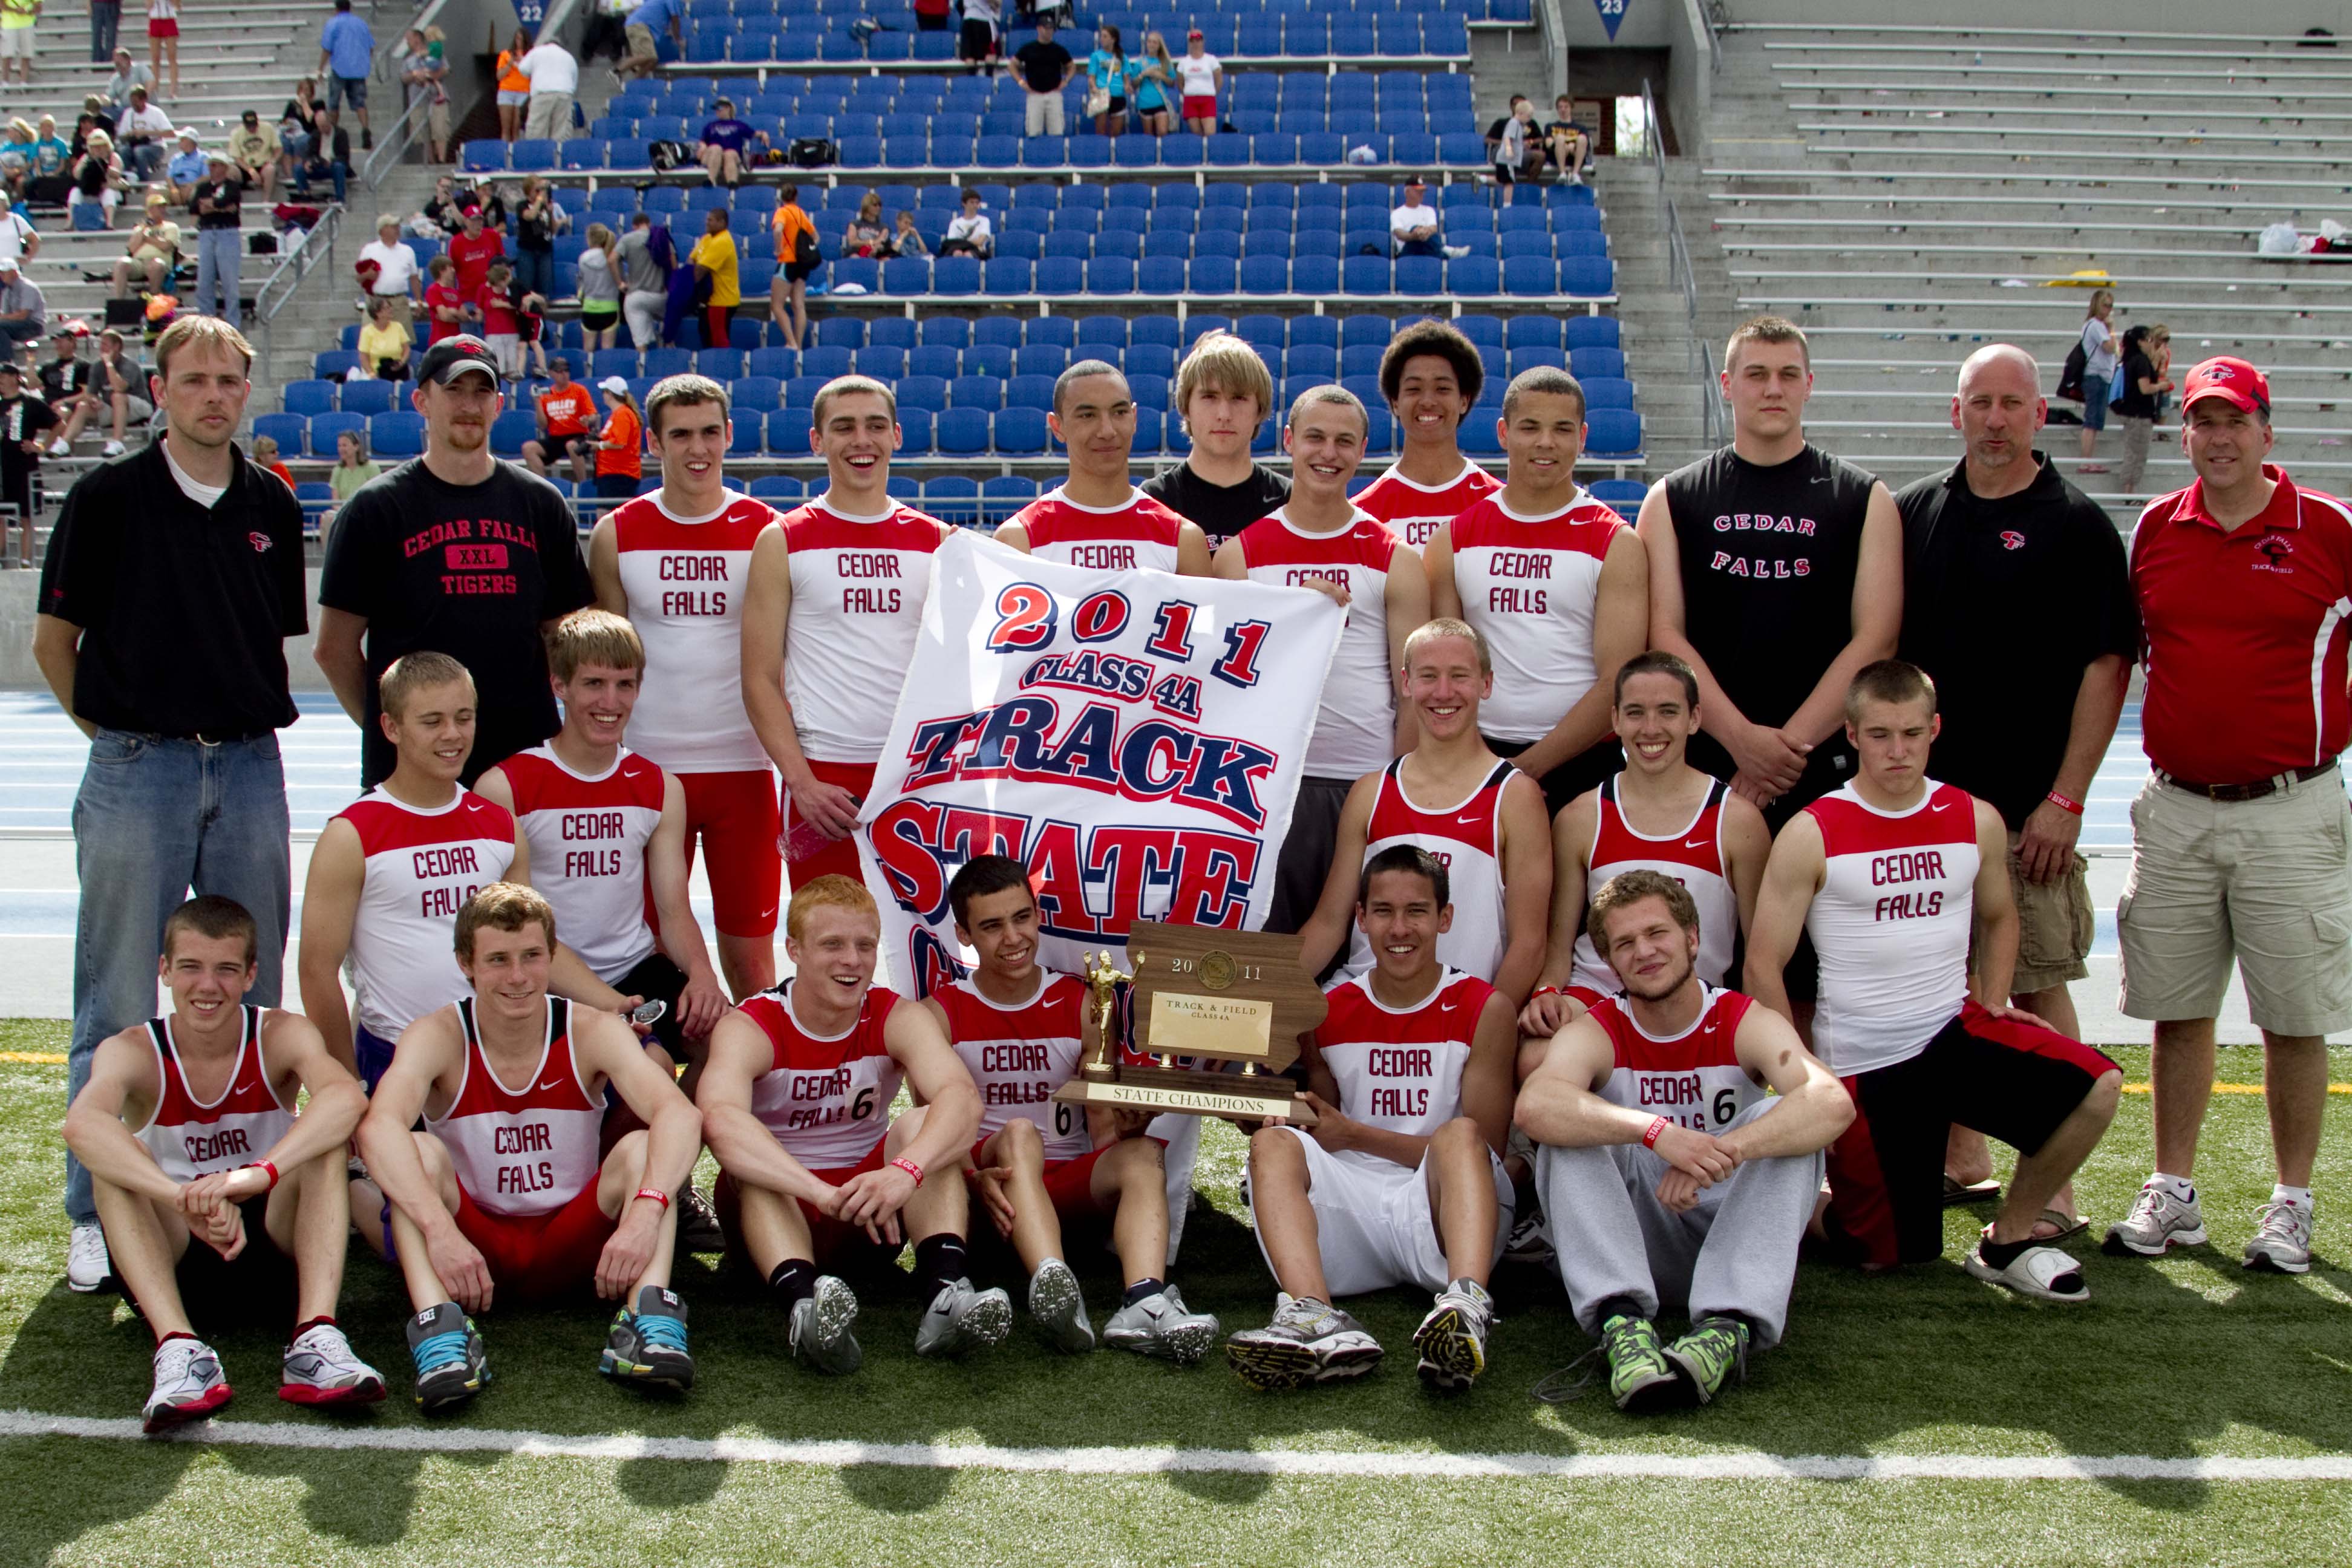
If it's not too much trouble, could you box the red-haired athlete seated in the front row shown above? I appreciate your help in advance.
[696,877,1014,1373]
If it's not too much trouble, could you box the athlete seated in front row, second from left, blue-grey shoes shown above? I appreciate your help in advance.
[350,881,704,1411]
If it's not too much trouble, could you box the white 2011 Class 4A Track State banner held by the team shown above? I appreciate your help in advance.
[858,531,1345,995]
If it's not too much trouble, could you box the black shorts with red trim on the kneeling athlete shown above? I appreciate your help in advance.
[1828,1001,2117,1269]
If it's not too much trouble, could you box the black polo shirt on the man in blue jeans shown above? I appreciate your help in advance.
[40,442,310,738]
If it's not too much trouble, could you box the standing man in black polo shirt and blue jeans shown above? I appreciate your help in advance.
[33,315,310,1290]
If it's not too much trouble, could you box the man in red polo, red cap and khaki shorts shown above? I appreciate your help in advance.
[2108,358,2352,1274]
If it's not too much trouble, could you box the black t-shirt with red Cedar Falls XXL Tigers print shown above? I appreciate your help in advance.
[318,459,595,788]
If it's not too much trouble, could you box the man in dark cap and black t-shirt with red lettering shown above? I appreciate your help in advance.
[318,334,595,788]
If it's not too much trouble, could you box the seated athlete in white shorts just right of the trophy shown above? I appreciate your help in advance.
[1226,844,1517,1390]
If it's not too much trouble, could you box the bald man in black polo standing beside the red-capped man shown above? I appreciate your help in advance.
[1896,343,2140,1236]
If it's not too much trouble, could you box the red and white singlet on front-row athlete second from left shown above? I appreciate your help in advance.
[426,997,604,1218]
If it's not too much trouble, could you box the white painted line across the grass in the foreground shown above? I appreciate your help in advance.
[0,1411,2352,1481]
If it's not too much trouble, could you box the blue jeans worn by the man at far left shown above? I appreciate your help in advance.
[66,728,294,1225]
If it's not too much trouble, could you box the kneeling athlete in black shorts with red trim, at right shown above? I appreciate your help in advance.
[1748,658,2124,1302]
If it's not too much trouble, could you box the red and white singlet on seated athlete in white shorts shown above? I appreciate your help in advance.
[1315,969,1494,1164]
